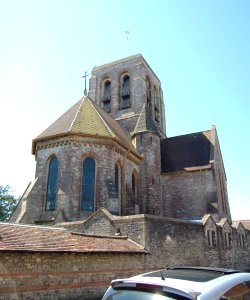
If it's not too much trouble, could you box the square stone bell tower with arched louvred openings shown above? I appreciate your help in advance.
[88,54,166,137]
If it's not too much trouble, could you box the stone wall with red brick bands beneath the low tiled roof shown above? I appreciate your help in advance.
[0,253,145,300]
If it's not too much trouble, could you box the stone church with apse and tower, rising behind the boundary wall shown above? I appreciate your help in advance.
[11,54,231,224]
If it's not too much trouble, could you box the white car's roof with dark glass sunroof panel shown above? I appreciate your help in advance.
[112,267,250,299]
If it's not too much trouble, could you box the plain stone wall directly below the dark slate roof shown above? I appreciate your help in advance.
[162,169,216,219]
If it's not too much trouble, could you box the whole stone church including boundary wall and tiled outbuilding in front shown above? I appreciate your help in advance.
[0,54,250,300]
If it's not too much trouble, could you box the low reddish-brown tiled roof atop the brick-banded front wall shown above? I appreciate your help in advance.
[0,223,145,253]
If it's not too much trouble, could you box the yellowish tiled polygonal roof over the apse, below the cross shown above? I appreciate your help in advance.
[32,97,137,154]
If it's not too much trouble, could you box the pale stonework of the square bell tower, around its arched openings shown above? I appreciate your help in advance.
[89,54,166,132]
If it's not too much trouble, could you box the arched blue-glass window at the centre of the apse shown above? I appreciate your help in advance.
[81,157,95,211]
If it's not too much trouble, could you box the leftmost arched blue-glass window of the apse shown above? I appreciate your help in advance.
[45,157,58,211]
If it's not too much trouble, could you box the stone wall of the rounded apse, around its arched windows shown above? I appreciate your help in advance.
[16,137,139,224]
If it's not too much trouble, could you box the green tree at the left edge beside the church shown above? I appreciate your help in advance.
[0,185,19,222]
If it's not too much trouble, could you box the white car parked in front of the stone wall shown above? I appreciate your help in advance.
[102,267,250,300]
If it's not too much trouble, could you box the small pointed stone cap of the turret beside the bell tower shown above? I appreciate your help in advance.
[133,104,159,133]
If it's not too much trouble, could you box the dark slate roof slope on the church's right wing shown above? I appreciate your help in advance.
[161,130,213,173]
